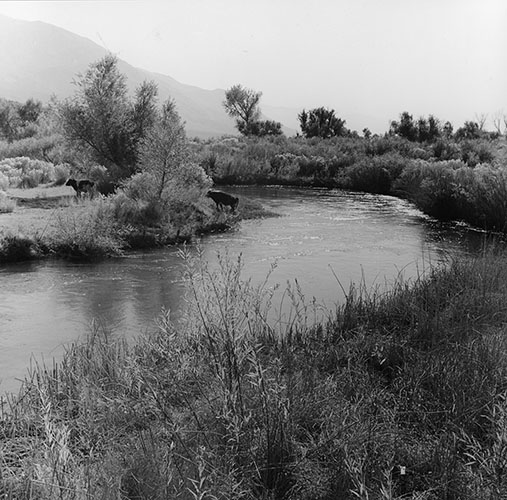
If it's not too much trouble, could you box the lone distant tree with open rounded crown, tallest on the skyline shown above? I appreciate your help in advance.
[222,85,262,135]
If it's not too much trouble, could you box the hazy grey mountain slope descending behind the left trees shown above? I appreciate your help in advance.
[0,15,298,138]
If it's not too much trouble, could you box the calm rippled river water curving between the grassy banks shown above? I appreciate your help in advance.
[0,187,481,393]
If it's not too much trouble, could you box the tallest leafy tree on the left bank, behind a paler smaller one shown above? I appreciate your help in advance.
[60,55,157,178]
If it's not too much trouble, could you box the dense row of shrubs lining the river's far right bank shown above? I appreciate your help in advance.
[193,136,507,231]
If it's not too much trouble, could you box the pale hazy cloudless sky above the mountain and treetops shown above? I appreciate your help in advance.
[0,0,507,132]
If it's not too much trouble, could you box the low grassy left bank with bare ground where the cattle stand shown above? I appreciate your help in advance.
[0,186,276,263]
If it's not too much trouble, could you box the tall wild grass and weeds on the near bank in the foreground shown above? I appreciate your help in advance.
[0,248,507,499]
